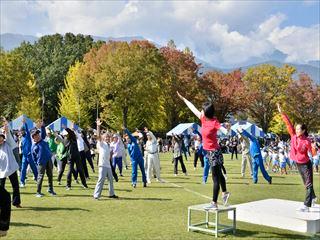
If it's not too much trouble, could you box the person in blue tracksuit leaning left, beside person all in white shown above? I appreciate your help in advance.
[123,127,147,188]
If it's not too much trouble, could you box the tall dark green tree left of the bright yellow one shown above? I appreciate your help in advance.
[15,33,93,121]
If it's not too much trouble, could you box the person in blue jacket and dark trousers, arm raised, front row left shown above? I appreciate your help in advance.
[31,122,56,197]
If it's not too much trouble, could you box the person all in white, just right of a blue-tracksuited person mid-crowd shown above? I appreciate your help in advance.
[145,128,162,183]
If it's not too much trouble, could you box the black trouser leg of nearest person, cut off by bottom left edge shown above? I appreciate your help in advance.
[0,186,11,231]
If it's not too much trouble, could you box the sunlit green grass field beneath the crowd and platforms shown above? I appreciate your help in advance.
[4,154,320,240]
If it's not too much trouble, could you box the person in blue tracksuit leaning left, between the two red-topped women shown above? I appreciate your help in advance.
[238,127,272,184]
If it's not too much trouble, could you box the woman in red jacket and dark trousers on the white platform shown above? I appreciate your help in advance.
[278,104,317,212]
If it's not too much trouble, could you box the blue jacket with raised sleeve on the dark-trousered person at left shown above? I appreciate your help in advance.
[31,126,51,165]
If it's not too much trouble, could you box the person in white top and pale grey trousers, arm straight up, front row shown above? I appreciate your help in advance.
[93,119,118,200]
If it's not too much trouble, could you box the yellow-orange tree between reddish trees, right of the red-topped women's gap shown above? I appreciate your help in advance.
[243,64,295,132]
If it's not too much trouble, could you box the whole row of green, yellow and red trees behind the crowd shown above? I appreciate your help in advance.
[0,34,320,133]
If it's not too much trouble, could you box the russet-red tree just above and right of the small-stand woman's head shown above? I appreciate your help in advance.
[200,70,247,122]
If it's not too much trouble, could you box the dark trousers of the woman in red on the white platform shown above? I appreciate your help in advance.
[297,161,316,207]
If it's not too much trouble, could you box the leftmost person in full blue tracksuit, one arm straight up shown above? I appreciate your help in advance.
[20,119,38,187]
